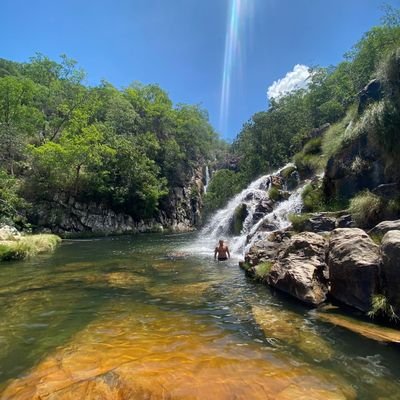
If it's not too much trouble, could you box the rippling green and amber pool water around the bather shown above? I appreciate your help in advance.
[0,235,400,400]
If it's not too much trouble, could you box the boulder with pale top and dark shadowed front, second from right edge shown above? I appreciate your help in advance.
[328,228,380,312]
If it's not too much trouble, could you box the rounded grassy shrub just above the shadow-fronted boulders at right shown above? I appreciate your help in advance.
[349,190,384,228]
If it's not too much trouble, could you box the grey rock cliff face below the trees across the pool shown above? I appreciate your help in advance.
[30,167,204,234]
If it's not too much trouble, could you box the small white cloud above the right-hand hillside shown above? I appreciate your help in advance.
[267,64,310,99]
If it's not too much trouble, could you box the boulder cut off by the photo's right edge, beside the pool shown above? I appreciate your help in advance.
[381,230,400,314]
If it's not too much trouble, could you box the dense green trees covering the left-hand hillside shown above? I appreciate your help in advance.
[0,55,220,222]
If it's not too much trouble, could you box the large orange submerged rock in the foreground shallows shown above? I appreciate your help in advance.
[0,302,356,400]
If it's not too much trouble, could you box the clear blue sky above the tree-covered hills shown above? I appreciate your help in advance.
[0,0,400,140]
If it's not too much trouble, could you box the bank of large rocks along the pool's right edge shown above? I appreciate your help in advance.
[240,219,400,322]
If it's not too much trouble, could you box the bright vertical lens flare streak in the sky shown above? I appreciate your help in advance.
[219,0,254,133]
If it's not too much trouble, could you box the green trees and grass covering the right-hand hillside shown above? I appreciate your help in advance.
[209,7,400,216]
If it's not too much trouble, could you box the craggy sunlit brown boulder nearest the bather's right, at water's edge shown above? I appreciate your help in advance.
[267,232,328,306]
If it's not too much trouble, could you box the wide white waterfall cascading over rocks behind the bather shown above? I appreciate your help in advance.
[186,164,304,256]
